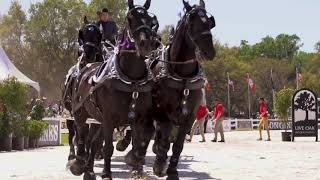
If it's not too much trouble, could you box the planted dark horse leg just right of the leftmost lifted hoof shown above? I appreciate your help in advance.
[83,124,101,180]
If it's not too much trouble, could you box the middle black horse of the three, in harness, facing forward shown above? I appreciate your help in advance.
[70,0,159,179]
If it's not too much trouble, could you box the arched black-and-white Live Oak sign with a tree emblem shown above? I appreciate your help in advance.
[292,89,318,141]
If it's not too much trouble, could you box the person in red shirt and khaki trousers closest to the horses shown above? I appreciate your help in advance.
[187,104,209,143]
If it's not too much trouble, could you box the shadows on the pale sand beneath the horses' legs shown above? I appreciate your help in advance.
[95,156,219,180]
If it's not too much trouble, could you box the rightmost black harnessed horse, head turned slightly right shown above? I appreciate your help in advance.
[149,0,215,180]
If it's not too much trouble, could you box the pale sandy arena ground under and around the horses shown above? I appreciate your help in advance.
[0,131,320,180]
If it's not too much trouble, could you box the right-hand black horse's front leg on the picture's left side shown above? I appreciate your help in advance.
[152,121,172,177]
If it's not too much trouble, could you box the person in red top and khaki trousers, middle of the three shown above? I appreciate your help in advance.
[212,99,225,142]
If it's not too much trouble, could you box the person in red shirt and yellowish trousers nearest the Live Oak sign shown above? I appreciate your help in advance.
[258,98,271,141]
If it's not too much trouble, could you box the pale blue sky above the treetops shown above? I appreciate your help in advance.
[0,0,320,51]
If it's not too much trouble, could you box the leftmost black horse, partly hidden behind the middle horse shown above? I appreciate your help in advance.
[62,17,103,160]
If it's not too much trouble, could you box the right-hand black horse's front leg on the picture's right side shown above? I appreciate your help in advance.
[167,123,192,180]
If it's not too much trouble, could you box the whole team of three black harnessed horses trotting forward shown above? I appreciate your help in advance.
[63,0,215,180]
